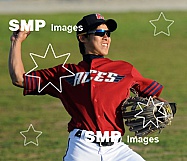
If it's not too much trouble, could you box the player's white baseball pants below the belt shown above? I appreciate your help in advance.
[63,129,145,161]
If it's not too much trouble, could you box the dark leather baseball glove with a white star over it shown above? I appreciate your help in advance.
[122,96,176,137]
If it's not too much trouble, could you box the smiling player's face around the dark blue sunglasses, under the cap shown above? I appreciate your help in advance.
[85,24,111,56]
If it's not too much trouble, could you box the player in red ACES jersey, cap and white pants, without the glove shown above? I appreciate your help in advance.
[9,14,163,161]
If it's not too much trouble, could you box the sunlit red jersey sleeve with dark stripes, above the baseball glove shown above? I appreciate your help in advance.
[132,67,163,97]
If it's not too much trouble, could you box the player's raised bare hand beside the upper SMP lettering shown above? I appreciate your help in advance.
[10,26,30,42]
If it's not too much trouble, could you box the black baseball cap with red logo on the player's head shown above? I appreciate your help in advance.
[77,13,117,36]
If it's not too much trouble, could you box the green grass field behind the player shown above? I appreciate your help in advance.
[0,12,187,161]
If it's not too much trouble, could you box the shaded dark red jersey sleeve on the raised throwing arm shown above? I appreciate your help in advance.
[23,66,63,97]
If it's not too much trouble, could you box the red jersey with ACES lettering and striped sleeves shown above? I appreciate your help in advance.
[24,55,163,135]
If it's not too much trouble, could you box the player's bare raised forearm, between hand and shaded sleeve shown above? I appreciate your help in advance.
[9,40,25,87]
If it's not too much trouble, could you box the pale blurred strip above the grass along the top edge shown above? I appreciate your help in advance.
[0,0,187,14]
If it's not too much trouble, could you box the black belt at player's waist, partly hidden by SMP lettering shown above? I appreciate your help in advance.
[75,130,121,147]
